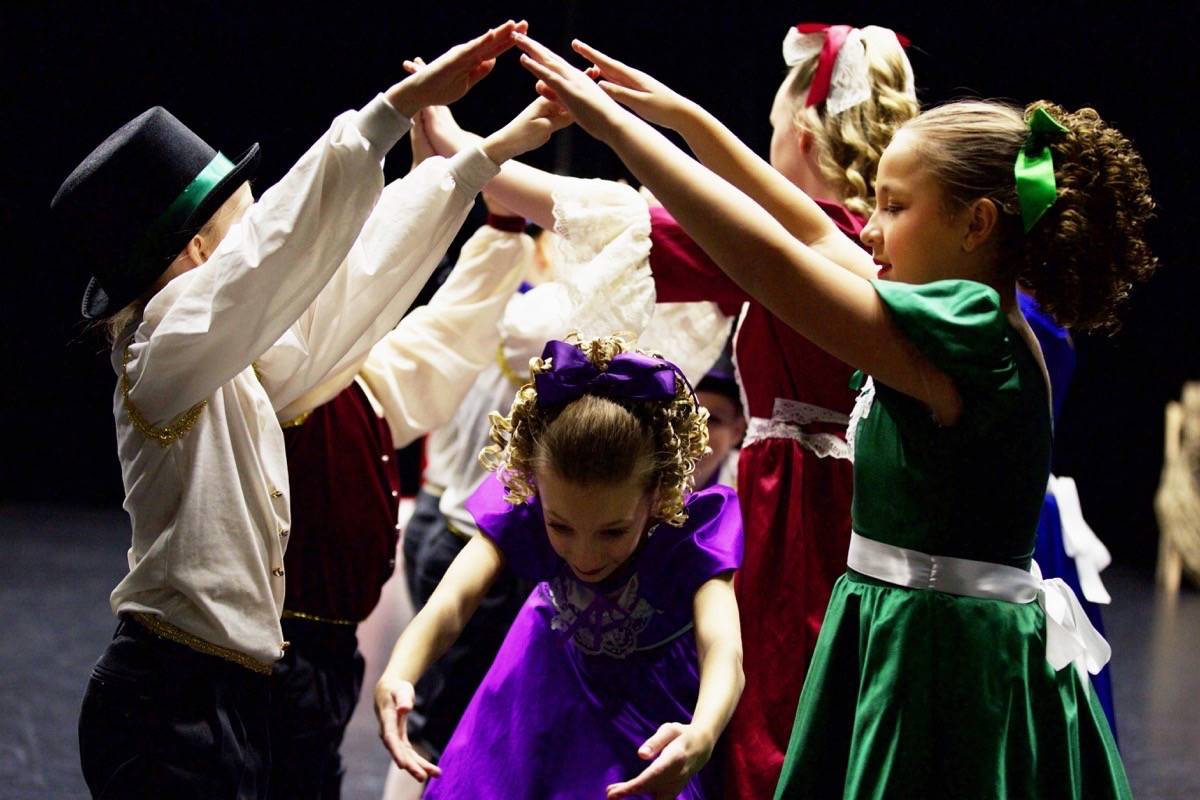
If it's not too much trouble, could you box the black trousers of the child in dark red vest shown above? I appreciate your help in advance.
[271,618,365,800]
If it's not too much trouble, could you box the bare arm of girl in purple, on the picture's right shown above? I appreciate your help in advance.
[607,572,745,800]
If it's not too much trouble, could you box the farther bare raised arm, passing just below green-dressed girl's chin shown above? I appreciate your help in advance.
[571,40,876,284]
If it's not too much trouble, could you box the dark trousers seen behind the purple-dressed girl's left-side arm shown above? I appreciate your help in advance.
[404,484,533,760]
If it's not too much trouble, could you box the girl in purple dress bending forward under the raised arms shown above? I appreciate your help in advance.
[376,337,743,799]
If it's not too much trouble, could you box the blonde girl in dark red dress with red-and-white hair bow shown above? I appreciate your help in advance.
[417,24,918,800]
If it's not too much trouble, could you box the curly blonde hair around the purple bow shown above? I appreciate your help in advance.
[479,335,708,528]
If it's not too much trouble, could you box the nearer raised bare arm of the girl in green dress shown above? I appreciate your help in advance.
[516,35,962,425]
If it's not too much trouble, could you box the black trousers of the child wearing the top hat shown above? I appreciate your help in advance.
[79,616,270,800]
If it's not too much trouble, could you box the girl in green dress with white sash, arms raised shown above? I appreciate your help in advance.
[517,35,1154,798]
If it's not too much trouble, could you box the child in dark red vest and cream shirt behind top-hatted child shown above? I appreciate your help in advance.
[271,112,537,800]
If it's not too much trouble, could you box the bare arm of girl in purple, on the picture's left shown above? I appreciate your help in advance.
[374,536,504,781]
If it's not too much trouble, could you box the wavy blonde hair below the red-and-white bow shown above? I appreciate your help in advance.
[784,25,920,217]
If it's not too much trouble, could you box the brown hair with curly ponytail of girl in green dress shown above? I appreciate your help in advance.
[905,101,1158,331]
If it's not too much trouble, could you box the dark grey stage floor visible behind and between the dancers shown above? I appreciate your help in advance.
[0,506,1200,800]
